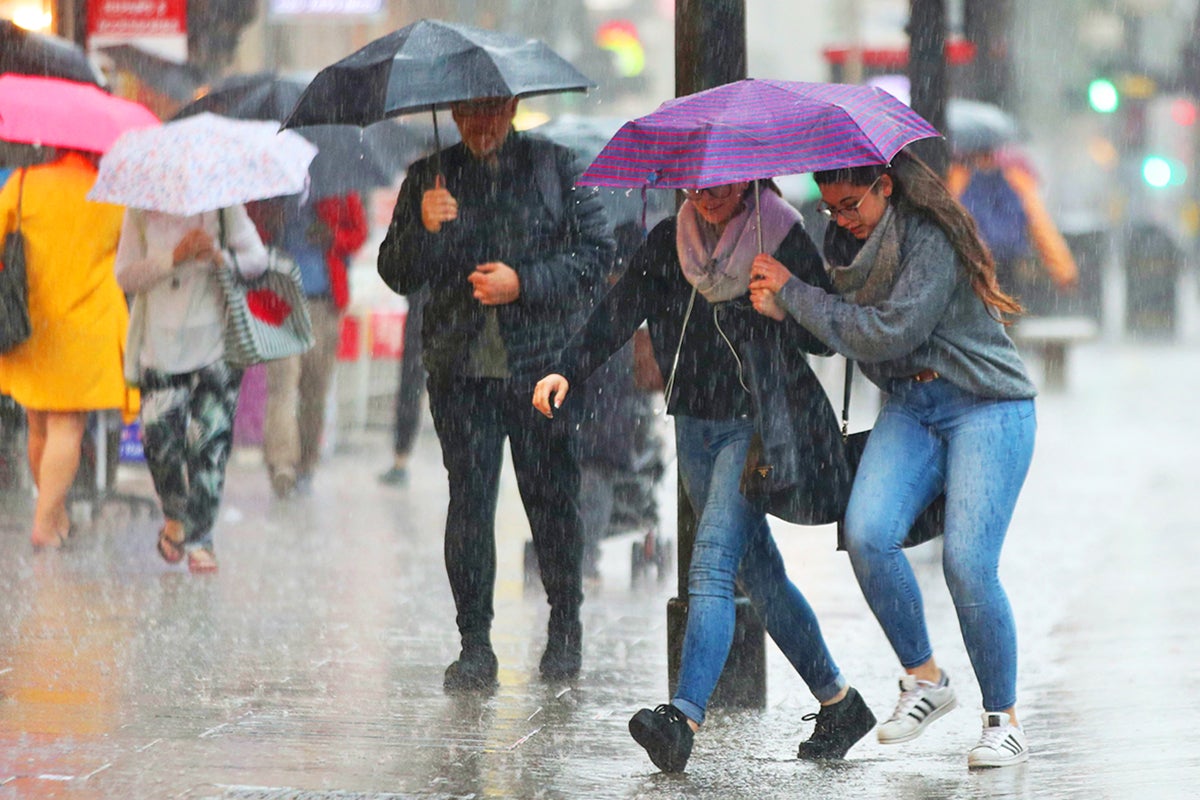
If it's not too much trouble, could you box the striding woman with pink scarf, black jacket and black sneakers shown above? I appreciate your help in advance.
[533,182,875,772]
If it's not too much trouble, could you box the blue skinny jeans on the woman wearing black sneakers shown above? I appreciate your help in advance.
[671,415,846,723]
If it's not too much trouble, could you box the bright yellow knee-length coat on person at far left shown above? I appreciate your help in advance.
[0,152,130,411]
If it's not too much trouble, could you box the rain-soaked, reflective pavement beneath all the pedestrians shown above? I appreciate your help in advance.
[0,344,1200,800]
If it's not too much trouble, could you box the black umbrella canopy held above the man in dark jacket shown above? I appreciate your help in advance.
[283,19,595,128]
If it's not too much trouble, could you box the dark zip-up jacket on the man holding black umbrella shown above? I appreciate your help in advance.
[378,131,613,380]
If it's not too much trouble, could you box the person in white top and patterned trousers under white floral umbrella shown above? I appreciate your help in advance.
[116,205,268,573]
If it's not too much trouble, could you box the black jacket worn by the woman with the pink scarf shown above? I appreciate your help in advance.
[554,218,829,420]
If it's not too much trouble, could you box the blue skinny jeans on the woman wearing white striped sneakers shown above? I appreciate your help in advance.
[846,379,1037,711]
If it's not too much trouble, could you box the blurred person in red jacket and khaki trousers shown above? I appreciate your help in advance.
[246,192,368,499]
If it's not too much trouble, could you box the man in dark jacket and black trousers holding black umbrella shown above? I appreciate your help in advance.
[379,97,613,691]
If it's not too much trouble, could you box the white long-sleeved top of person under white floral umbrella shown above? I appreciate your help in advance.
[115,205,268,374]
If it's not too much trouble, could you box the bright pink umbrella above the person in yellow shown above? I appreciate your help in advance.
[0,74,158,152]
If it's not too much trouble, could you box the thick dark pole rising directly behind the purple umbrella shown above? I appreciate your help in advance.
[667,0,767,708]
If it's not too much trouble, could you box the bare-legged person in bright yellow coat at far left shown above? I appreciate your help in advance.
[0,151,128,548]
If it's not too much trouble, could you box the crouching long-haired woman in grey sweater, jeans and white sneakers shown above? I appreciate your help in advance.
[750,152,1037,768]
